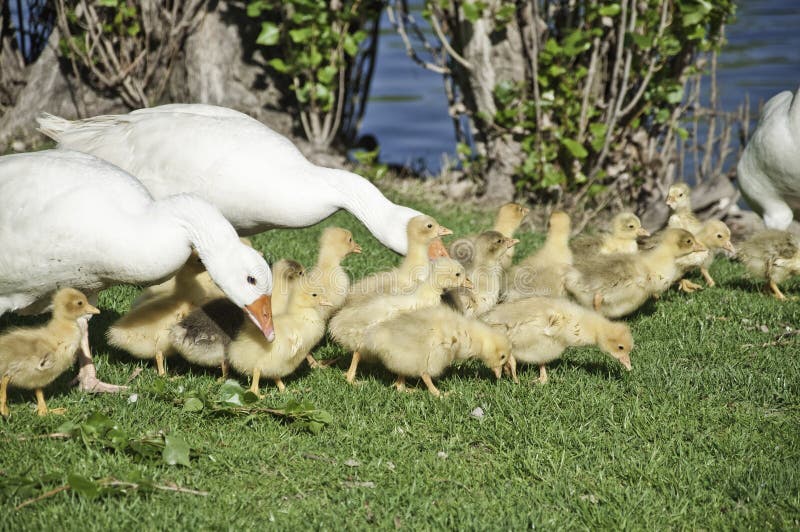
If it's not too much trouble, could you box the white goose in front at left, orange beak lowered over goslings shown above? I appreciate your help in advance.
[0,150,275,391]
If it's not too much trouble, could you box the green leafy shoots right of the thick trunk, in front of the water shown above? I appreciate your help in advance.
[504,0,734,196]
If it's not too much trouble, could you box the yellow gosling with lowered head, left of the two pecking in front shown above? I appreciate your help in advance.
[364,305,510,397]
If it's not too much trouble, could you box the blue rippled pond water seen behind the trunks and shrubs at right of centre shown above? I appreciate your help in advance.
[361,0,800,178]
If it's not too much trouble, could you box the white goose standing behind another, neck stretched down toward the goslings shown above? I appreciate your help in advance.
[39,104,432,255]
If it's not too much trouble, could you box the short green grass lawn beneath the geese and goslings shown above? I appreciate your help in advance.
[0,197,800,530]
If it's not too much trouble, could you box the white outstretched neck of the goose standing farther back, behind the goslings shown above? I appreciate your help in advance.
[315,166,421,255]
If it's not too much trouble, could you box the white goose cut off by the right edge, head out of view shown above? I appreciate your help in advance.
[737,89,800,229]
